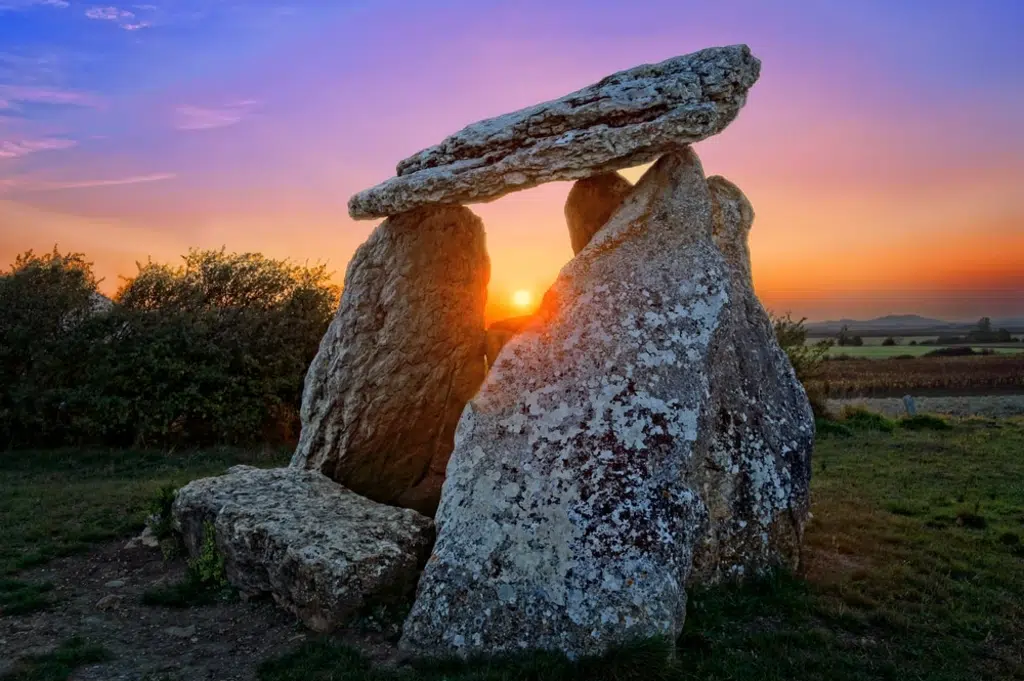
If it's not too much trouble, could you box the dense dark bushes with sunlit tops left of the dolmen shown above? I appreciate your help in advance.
[0,248,339,448]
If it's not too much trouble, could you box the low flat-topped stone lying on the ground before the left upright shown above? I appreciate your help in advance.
[173,466,433,631]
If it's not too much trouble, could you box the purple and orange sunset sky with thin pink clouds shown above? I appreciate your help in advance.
[0,0,1024,320]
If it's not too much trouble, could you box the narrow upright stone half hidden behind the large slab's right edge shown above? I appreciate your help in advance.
[690,176,814,584]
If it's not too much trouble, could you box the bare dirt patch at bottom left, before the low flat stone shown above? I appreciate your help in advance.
[0,540,315,681]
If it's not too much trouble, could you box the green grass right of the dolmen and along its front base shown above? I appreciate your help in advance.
[260,416,1024,681]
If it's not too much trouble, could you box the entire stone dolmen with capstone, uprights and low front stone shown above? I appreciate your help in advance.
[174,45,814,657]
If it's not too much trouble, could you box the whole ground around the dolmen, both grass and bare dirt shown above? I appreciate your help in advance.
[0,419,1024,681]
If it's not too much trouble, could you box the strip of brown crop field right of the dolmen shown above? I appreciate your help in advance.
[810,353,1024,398]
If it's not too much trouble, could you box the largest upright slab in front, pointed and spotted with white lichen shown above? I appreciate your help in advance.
[401,150,729,655]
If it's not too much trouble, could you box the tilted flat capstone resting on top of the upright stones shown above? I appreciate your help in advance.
[348,45,761,219]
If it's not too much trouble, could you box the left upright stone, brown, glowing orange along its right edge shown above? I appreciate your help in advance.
[292,206,489,515]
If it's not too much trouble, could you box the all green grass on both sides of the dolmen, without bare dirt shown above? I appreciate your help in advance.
[0,417,1024,681]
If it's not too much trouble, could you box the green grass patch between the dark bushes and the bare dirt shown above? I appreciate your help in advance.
[0,449,288,577]
